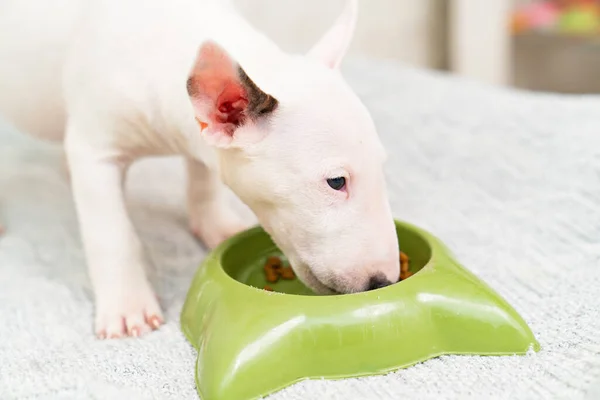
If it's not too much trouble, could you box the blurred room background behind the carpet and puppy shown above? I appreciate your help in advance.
[236,0,600,93]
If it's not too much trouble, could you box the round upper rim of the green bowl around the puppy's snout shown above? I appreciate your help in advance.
[201,219,449,299]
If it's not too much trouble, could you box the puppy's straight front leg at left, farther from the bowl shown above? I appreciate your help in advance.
[65,129,163,338]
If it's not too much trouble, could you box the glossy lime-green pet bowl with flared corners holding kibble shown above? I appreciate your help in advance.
[181,221,540,400]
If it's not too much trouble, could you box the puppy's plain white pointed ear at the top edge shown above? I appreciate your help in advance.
[308,0,358,69]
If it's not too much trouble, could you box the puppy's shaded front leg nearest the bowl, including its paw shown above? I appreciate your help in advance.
[187,159,248,249]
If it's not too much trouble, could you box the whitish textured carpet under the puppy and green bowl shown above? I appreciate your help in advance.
[0,62,600,400]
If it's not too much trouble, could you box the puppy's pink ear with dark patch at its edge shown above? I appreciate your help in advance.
[187,42,278,147]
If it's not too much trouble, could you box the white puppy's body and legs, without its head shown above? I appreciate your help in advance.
[0,0,277,336]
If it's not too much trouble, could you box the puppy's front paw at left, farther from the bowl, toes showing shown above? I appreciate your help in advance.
[96,284,164,339]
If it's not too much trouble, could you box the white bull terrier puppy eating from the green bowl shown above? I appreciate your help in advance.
[0,0,400,338]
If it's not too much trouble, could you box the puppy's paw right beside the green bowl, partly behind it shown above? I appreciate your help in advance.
[190,206,249,249]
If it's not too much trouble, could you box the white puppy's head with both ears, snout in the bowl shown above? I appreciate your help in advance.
[188,0,400,293]
